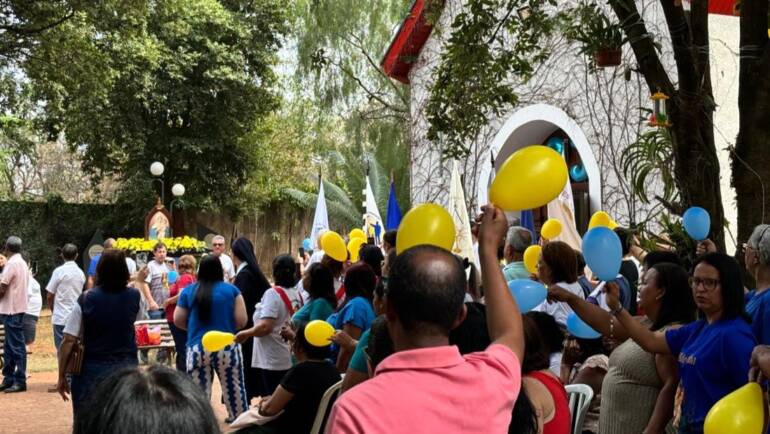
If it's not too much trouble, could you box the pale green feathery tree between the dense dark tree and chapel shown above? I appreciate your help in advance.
[292,0,410,210]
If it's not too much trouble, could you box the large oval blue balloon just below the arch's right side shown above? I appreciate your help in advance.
[583,226,623,281]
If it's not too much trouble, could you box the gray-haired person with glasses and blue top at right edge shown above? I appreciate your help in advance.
[743,225,770,345]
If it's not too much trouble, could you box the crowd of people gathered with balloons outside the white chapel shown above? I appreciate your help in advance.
[0,210,770,434]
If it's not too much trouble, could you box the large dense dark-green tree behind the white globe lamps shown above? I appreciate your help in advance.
[16,0,286,214]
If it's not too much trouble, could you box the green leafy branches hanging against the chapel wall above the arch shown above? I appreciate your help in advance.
[426,0,559,158]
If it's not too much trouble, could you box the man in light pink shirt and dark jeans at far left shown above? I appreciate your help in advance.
[0,236,29,393]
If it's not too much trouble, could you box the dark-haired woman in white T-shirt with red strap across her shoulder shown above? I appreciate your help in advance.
[235,255,299,396]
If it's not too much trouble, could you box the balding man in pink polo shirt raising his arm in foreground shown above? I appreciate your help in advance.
[327,206,524,434]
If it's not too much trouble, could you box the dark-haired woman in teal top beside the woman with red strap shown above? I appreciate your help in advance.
[291,262,337,327]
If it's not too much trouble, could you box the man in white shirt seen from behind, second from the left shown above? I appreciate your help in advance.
[45,244,86,353]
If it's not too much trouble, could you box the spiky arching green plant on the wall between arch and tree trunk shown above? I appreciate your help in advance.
[620,128,678,203]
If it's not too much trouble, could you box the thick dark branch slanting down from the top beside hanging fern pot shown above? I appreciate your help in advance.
[609,0,675,95]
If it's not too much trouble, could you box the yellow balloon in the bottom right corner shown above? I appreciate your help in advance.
[703,382,765,434]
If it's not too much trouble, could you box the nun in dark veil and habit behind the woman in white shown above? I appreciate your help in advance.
[231,237,270,400]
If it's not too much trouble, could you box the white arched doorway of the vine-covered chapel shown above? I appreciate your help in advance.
[478,104,602,233]
